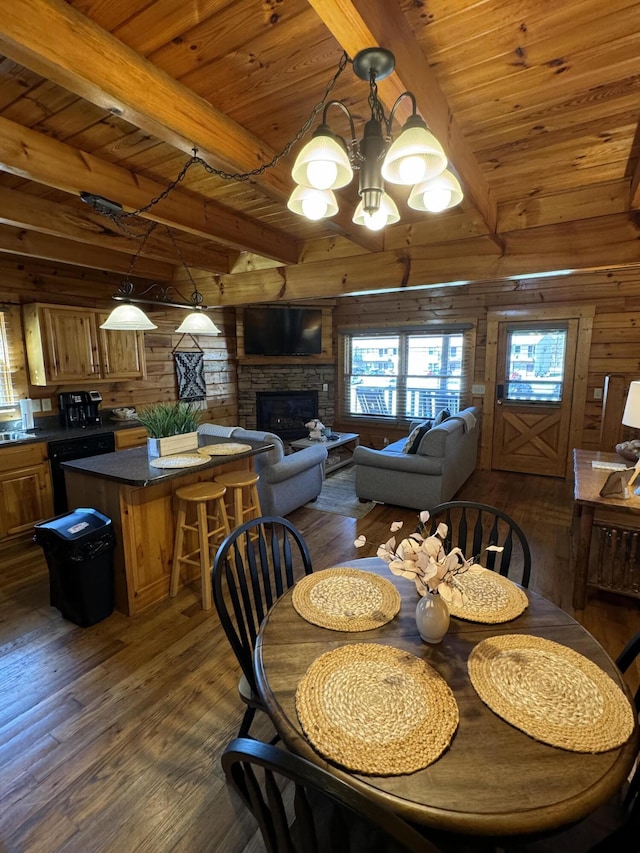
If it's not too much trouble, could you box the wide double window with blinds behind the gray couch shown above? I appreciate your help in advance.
[342,325,471,421]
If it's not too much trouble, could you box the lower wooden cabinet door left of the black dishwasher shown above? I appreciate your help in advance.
[0,464,53,539]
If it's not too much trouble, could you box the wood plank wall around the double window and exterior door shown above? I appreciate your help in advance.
[334,270,640,450]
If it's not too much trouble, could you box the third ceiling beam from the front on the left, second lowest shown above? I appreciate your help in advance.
[0,186,232,273]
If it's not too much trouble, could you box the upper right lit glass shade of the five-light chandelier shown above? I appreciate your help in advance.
[382,115,447,184]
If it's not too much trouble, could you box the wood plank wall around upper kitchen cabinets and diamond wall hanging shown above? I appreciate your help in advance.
[0,257,238,425]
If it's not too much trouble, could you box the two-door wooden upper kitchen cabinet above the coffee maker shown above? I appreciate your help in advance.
[23,303,145,385]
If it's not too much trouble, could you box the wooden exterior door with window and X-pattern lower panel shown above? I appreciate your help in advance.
[492,319,578,477]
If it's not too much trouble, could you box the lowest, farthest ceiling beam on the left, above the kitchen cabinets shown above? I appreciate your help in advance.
[0,225,175,281]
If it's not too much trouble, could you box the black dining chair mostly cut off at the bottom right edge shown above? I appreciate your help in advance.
[506,631,640,853]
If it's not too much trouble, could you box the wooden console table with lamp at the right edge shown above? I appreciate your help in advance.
[572,450,640,610]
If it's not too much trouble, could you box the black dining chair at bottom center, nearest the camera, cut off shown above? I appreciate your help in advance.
[222,738,438,853]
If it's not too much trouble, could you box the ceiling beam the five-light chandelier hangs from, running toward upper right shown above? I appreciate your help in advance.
[308,0,497,234]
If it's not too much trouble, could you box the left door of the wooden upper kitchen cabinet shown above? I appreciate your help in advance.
[41,307,100,382]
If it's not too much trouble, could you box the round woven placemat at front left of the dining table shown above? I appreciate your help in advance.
[296,643,458,776]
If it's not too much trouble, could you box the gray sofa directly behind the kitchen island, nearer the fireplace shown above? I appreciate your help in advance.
[198,424,327,516]
